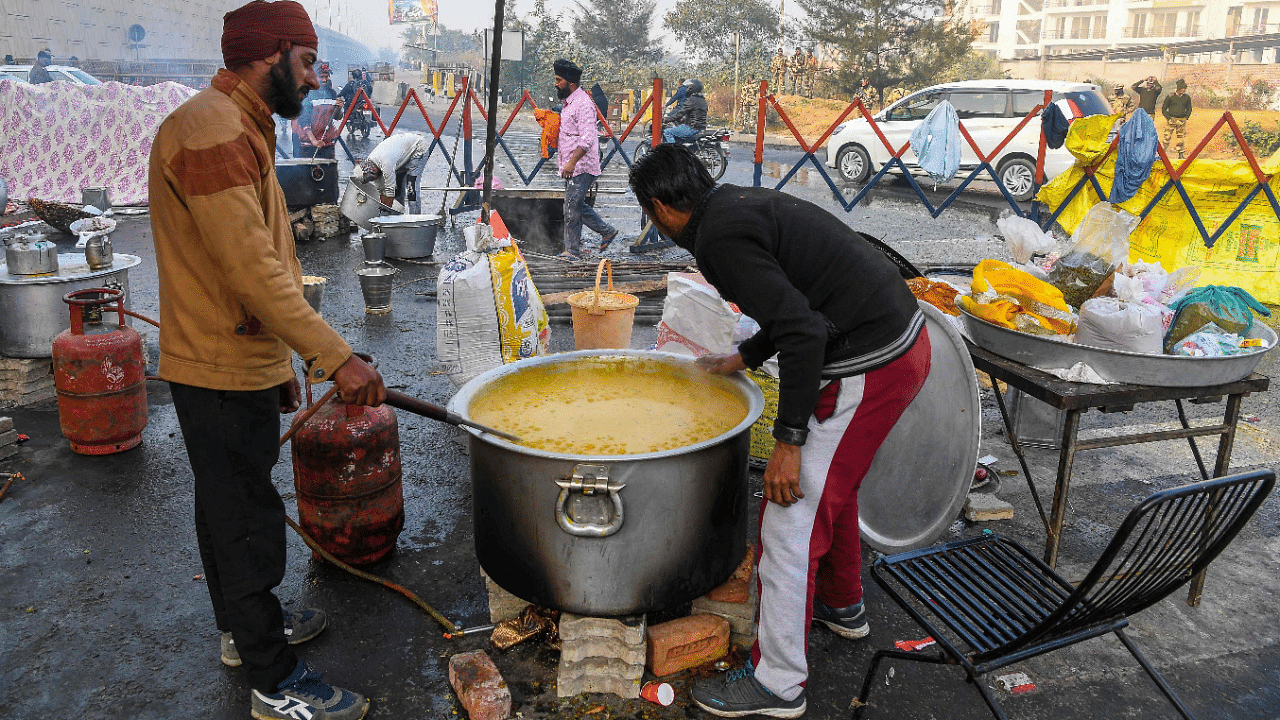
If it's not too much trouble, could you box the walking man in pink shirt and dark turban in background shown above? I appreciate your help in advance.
[553,59,618,260]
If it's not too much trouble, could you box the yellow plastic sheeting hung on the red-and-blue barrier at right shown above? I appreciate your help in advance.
[1037,118,1280,305]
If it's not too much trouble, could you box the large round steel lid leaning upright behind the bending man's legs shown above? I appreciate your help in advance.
[858,302,982,553]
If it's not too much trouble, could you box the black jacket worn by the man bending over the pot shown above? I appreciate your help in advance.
[675,184,924,430]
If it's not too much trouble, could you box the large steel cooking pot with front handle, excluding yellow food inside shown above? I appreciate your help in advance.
[449,350,764,616]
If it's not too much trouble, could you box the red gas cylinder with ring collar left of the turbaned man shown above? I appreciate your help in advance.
[54,287,147,455]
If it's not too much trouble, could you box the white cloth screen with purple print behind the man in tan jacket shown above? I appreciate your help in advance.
[0,79,196,205]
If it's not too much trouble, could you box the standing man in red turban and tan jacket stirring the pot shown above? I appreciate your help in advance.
[150,0,376,720]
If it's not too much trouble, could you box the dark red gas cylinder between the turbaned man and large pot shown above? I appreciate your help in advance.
[292,398,404,565]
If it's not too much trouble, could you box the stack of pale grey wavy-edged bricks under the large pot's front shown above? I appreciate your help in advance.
[556,612,646,698]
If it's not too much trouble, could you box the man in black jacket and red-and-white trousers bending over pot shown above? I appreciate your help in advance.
[631,145,931,717]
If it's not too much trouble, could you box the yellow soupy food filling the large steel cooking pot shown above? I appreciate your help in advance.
[467,357,748,455]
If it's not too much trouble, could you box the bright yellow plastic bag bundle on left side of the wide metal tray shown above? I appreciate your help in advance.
[960,260,1075,336]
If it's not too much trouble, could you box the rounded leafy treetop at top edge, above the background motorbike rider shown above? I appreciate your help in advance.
[662,0,778,63]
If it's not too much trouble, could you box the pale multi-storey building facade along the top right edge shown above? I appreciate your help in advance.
[952,0,1280,61]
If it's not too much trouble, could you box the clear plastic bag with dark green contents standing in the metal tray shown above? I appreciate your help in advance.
[1048,202,1139,307]
